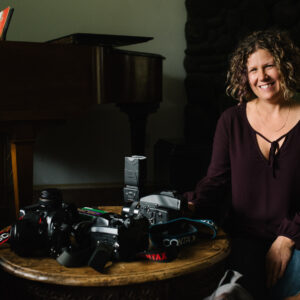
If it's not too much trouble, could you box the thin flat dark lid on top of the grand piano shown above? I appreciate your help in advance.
[47,33,153,47]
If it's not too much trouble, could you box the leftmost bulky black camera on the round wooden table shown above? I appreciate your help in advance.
[9,189,79,257]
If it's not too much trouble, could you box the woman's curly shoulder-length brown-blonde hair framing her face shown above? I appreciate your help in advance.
[226,30,300,102]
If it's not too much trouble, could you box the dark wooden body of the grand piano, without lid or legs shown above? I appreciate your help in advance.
[0,41,163,121]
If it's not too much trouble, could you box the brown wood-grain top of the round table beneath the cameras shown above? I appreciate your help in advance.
[0,207,230,287]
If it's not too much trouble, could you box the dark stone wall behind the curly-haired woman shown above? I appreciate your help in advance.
[184,0,300,144]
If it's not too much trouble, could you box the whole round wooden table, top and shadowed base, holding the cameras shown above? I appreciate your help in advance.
[0,207,230,300]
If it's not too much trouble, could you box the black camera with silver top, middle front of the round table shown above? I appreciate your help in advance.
[57,213,149,272]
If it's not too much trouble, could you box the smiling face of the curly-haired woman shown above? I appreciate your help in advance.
[247,49,282,102]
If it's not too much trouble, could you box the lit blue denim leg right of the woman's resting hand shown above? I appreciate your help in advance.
[271,250,300,300]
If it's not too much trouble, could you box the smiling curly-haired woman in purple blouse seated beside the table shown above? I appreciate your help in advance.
[185,30,300,300]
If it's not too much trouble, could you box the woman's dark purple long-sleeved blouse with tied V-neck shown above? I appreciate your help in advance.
[185,104,300,249]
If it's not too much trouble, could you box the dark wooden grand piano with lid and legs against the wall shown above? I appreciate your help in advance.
[0,34,163,223]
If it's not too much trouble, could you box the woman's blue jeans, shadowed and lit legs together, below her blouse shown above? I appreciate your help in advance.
[226,237,300,300]
